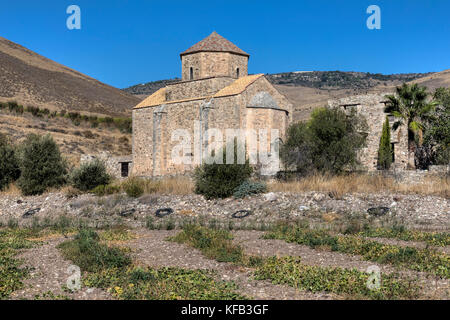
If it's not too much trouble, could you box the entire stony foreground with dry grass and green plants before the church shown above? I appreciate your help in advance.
[0,178,450,300]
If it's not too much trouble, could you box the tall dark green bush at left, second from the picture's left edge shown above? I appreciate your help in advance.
[18,134,67,195]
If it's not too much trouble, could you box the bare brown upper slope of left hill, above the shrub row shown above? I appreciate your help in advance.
[0,37,140,116]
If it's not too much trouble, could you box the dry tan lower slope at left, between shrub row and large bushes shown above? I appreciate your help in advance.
[0,112,131,164]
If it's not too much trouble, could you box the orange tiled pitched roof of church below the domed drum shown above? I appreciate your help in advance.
[133,74,264,109]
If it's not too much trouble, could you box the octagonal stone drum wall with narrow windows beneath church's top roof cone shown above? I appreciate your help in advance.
[181,52,248,81]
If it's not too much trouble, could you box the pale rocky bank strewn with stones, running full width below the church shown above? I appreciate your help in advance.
[0,192,450,230]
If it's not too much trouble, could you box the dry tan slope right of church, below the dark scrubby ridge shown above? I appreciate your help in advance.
[275,70,450,121]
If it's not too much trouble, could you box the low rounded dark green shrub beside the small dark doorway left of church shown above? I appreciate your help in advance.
[70,159,111,191]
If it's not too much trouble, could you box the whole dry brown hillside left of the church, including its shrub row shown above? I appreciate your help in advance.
[0,37,140,164]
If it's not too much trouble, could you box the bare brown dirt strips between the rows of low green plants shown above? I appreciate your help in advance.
[7,229,450,300]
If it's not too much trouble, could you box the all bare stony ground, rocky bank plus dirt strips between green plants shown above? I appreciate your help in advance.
[0,192,450,300]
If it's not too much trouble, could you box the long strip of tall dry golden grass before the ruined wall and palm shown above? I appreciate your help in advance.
[268,174,450,199]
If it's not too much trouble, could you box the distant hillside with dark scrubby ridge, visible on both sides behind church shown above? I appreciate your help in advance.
[123,71,436,121]
